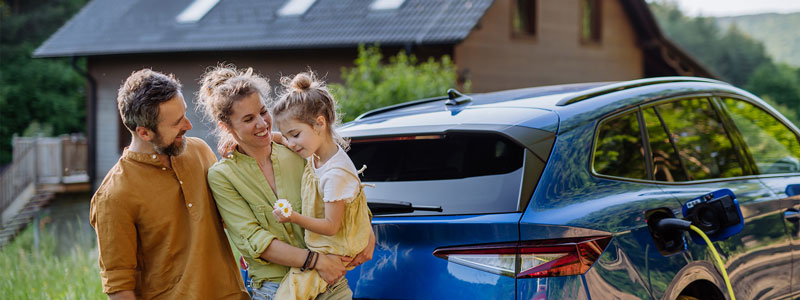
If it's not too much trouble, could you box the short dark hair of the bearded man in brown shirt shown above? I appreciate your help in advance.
[117,69,181,132]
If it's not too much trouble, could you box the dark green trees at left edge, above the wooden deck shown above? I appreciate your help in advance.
[0,0,86,165]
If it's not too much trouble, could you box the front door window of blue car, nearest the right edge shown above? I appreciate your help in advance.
[722,98,800,174]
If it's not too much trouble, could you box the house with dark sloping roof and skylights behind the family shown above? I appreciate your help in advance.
[34,0,714,186]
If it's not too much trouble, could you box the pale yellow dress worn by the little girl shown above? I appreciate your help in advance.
[275,155,371,299]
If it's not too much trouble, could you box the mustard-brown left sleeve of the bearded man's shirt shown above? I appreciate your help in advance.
[89,192,138,294]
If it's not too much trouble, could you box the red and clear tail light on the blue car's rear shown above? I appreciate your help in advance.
[433,236,611,278]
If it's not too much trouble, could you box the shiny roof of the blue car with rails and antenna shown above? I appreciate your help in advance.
[342,77,757,135]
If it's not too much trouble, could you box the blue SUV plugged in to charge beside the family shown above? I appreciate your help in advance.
[342,77,800,299]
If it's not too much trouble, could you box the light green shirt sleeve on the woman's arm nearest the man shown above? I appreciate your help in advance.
[208,168,277,264]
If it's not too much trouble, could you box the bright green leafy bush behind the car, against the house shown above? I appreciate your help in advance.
[330,45,470,121]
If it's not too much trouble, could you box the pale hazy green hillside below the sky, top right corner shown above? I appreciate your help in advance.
[716,12,800,67]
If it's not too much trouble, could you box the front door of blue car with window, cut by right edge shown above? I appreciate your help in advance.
[719,97,800,295]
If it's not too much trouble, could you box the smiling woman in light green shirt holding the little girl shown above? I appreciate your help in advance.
[197,65,375,299]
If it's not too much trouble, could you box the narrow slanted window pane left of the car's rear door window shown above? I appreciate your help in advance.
[642,107,687,182]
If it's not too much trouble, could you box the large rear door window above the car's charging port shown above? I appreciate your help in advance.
[655,98,744,180]
